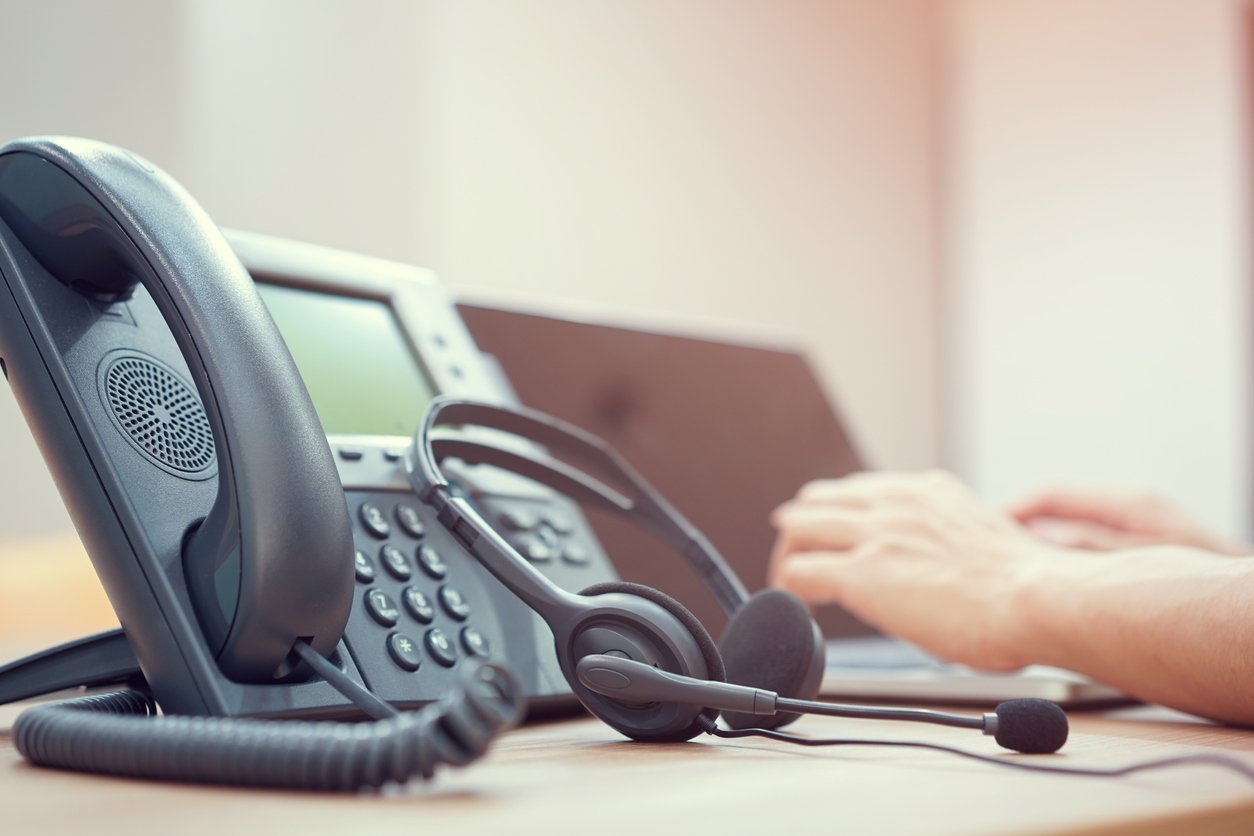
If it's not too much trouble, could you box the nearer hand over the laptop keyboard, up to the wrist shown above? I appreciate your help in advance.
[770,473,1066,671]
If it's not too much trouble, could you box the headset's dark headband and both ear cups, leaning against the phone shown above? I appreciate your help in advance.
[405,397,823,741]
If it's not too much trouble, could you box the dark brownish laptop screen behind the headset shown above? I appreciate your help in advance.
[459,303,874,637]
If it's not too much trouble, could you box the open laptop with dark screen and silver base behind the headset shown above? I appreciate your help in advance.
[459,298,1126,707]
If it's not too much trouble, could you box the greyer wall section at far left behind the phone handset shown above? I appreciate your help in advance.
[0,0,187,538]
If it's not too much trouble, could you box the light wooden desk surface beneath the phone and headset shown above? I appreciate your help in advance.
[0,543,1254,836]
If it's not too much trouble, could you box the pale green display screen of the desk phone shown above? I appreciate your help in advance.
[257,283,436,436]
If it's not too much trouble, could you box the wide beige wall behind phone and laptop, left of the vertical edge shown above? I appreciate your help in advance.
[0,0,939,531]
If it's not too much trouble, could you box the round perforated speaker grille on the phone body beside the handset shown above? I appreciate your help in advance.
[100,352,217,479]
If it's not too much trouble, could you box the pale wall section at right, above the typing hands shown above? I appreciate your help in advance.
[944,0,1250,534]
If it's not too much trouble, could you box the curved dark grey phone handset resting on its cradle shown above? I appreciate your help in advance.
[0,138,352,682]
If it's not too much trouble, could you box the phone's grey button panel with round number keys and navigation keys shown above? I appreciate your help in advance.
[345,483,607,707]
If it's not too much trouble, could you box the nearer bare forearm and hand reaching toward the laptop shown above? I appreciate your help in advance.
[771,474,1254,724]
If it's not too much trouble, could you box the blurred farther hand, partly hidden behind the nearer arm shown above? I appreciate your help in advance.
[1011,489,1250,555]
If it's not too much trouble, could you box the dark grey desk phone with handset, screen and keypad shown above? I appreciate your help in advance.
[0,138,616,717]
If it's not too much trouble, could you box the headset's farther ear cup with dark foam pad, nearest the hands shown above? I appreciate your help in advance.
[719,589,825,728]
